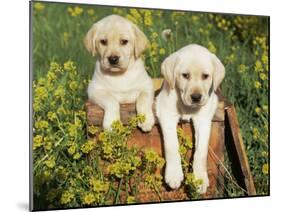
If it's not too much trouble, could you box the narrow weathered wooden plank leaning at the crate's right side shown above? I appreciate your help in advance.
[223,104,256,196]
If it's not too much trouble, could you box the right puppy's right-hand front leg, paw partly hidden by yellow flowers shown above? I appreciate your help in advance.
[193,119,211,194]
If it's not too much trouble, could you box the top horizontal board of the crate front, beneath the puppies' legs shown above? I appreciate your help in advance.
[85,101,224,126]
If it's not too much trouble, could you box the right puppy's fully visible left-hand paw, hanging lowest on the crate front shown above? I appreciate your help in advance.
[165,161,183,189]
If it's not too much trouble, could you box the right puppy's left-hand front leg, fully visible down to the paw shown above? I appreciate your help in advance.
[159,114,183,189]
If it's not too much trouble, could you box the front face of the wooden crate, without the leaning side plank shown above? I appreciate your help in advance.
[86,101,225,202]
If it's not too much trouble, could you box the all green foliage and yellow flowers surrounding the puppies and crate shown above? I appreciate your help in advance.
[32,2,269,208]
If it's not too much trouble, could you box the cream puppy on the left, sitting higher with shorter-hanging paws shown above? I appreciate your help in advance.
[84,15,154,131]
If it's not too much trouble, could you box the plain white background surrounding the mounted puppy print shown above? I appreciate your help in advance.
[0,0,281,212]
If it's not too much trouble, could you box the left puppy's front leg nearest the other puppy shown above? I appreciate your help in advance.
[136,91,155,132]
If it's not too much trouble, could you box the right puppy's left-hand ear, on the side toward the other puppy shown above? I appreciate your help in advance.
[161,53,178,89]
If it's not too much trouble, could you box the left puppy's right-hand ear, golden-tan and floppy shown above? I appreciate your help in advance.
[132,24,148,58]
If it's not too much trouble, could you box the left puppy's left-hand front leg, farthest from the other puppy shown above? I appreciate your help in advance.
[89,90,120,130]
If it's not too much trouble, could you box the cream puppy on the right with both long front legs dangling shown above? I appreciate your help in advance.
[156,44,225,194]
